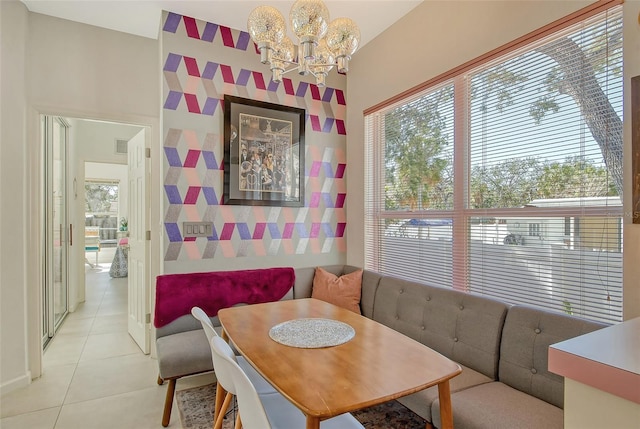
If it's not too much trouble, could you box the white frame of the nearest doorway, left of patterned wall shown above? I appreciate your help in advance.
[25,105,164,379]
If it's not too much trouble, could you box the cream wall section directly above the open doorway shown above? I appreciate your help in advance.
[27,13,160,119]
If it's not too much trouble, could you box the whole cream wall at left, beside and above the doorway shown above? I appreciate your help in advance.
[0,1,161,392]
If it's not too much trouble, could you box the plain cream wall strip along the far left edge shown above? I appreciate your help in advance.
[0,2,30,392]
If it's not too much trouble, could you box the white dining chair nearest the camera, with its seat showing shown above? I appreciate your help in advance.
[211,337,364,429]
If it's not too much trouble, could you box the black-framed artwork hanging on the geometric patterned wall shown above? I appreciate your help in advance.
[223,95,305,207]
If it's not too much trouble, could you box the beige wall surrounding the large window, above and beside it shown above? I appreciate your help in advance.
[347,0,640,319]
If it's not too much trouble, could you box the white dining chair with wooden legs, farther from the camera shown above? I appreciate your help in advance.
[191,307,277,429]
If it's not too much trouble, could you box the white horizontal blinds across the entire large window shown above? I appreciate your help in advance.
[365,6,623,322]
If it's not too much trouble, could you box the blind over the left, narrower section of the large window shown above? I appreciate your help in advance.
[365,82,454,287]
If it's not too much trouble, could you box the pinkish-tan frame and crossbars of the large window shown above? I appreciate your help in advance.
[364,0,624,317]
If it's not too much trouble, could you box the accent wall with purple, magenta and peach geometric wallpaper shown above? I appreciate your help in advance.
[161,12,347,265]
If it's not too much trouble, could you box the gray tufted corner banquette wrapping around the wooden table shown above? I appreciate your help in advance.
[156,265,605,429]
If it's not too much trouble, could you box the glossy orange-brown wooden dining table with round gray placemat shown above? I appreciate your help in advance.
[215,298,462,429]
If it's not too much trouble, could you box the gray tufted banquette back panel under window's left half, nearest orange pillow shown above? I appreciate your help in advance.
[372,276,508,380]
